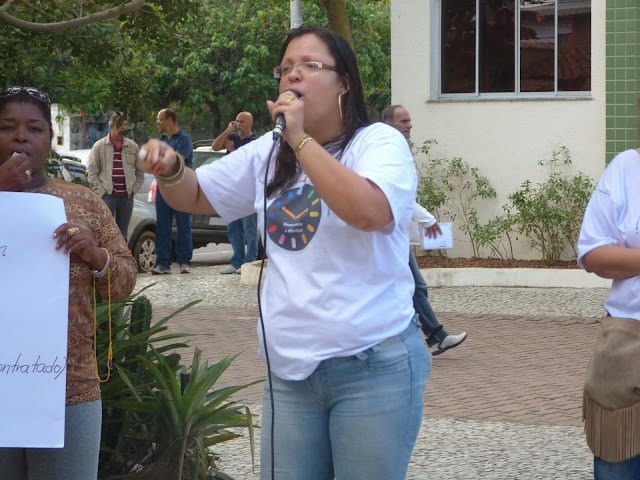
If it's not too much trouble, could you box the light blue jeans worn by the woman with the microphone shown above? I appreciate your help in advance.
[260,320,431,480]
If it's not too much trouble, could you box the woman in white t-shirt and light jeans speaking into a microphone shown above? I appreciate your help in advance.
[141,26,431,480]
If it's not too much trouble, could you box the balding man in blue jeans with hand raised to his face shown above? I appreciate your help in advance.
[211,112,258,274]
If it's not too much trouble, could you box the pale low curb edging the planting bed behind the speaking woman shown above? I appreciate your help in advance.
[240,260,611,289]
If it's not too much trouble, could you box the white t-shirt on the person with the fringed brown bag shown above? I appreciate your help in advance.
[578,150,640,320]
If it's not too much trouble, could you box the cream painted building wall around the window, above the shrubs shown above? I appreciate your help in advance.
[391,0,605,258]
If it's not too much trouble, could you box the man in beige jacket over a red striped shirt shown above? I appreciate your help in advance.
[87,113,144,239]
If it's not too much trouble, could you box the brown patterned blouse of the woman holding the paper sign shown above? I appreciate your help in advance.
[31,179,137,405]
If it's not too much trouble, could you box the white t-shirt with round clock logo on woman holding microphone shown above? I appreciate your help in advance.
[196,123,416,380]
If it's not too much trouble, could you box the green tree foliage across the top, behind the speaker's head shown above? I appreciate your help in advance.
[0,0,391,142]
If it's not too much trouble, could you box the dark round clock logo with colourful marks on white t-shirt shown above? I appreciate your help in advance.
[267,184,322,251]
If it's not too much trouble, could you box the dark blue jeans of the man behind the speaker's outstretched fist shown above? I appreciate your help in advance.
[156,190,193,268]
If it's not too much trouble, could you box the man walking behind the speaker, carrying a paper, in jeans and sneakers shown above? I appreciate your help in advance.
[382,105,467,355]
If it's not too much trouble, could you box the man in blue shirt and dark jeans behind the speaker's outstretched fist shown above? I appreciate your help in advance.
[151,108,193,275]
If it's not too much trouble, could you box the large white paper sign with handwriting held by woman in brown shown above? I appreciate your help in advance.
[0,192,69,448]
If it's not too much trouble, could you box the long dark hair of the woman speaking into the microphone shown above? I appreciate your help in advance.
[267,25,371,197]
